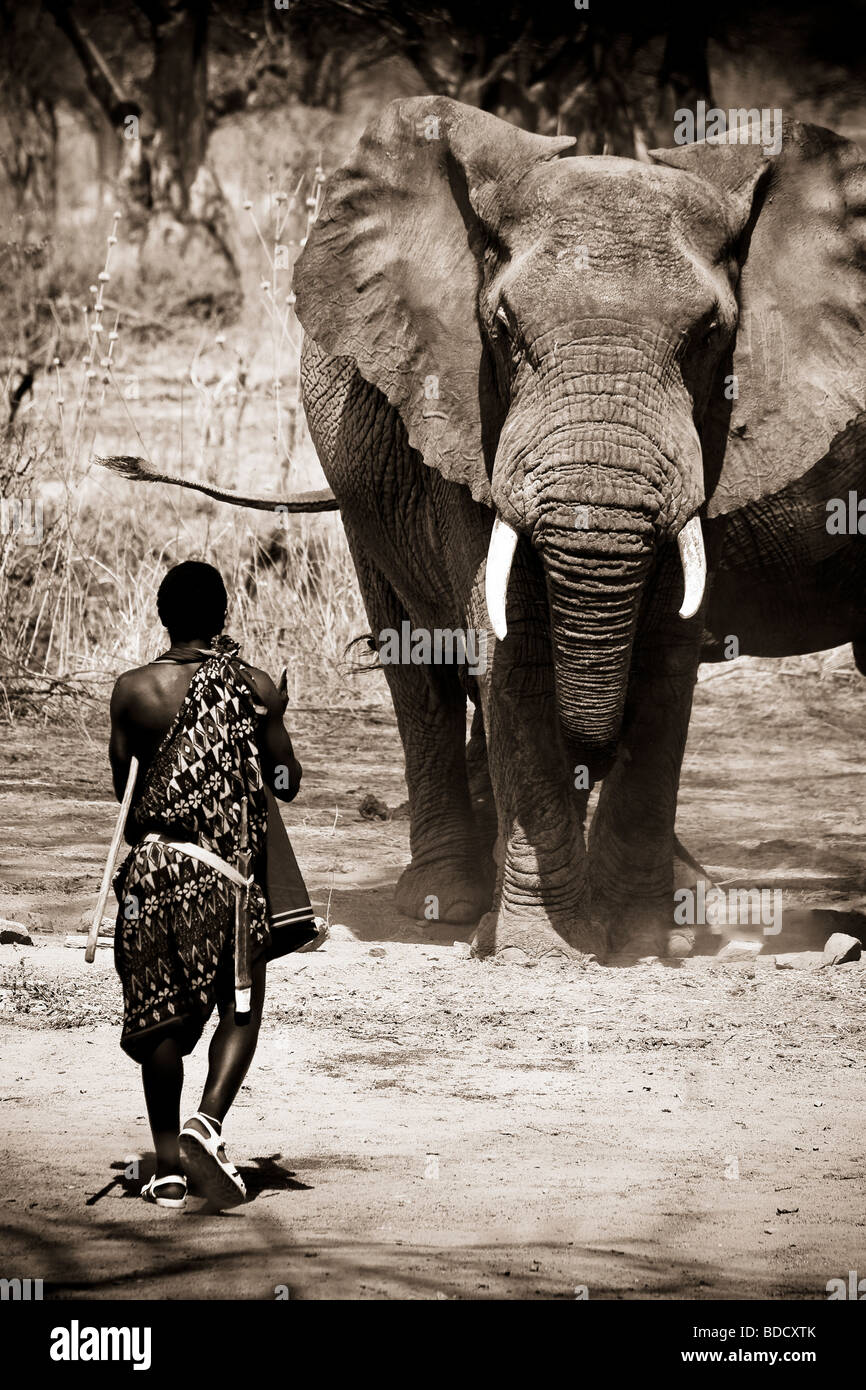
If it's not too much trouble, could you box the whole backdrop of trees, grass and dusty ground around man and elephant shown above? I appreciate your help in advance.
[0,0,866,1301]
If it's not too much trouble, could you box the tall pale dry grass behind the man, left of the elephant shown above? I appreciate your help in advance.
[0,176,385,720]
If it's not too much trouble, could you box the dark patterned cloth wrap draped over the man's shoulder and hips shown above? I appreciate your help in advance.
[114,638,271,1059]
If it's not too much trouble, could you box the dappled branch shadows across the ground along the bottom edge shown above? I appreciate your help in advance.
[0,1208,823,1301]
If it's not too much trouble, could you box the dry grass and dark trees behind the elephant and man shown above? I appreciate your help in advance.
[0,0,866,719]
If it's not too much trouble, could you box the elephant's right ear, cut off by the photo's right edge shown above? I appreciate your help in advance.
[652,121,866,516]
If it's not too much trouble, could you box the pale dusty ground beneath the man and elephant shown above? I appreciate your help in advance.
[0,656,866,1298]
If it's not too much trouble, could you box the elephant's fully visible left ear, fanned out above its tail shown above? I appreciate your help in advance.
[295,97,574,502]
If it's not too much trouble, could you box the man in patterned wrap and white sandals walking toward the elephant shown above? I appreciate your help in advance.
[110,560,317,1208]
